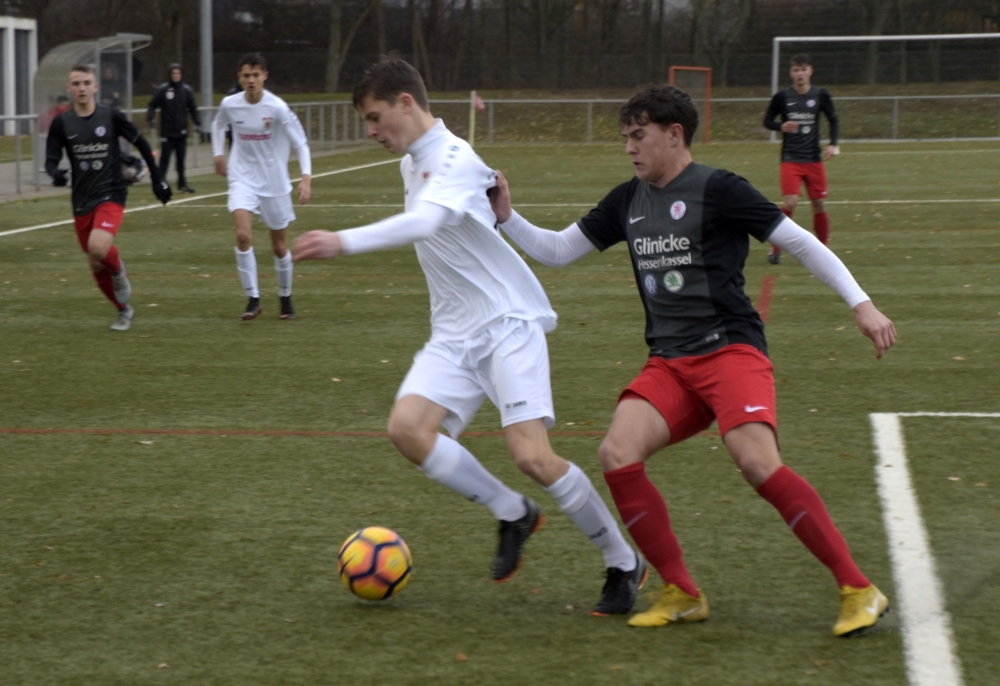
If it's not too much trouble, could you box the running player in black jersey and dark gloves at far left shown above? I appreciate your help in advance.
[45,64,171,331]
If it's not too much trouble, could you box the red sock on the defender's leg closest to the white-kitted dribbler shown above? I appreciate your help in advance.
[604,462,698,598]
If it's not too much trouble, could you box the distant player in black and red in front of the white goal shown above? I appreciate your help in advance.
[764,53,840,264]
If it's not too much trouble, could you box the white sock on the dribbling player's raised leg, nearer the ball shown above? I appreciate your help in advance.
[420,434,528,520]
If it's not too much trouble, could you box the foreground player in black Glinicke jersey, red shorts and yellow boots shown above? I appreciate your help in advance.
[491,86,895,636]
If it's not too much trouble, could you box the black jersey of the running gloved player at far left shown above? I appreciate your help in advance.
[45,105,139,217]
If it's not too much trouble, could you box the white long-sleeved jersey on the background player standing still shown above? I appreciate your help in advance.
[212,91,312,198]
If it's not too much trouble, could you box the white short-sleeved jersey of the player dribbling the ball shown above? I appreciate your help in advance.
[400,120,556,340]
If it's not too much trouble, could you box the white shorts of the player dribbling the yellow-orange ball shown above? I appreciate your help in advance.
[396,319,555,438]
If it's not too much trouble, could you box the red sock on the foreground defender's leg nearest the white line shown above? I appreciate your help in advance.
[756,465,871,588]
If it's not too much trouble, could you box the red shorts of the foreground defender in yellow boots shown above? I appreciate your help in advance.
[618,343,778,444]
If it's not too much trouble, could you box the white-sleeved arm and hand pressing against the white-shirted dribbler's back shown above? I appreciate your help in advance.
[489,171,597,268]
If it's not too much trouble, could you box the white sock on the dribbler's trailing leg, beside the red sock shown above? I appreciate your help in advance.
[545,462,636,572]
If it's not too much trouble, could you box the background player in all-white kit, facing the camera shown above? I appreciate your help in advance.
[212,53,312,319]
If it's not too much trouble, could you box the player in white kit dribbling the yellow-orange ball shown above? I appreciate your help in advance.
[293,58,647,615]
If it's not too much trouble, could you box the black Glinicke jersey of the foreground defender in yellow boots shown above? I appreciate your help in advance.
[578,162,784,358]
